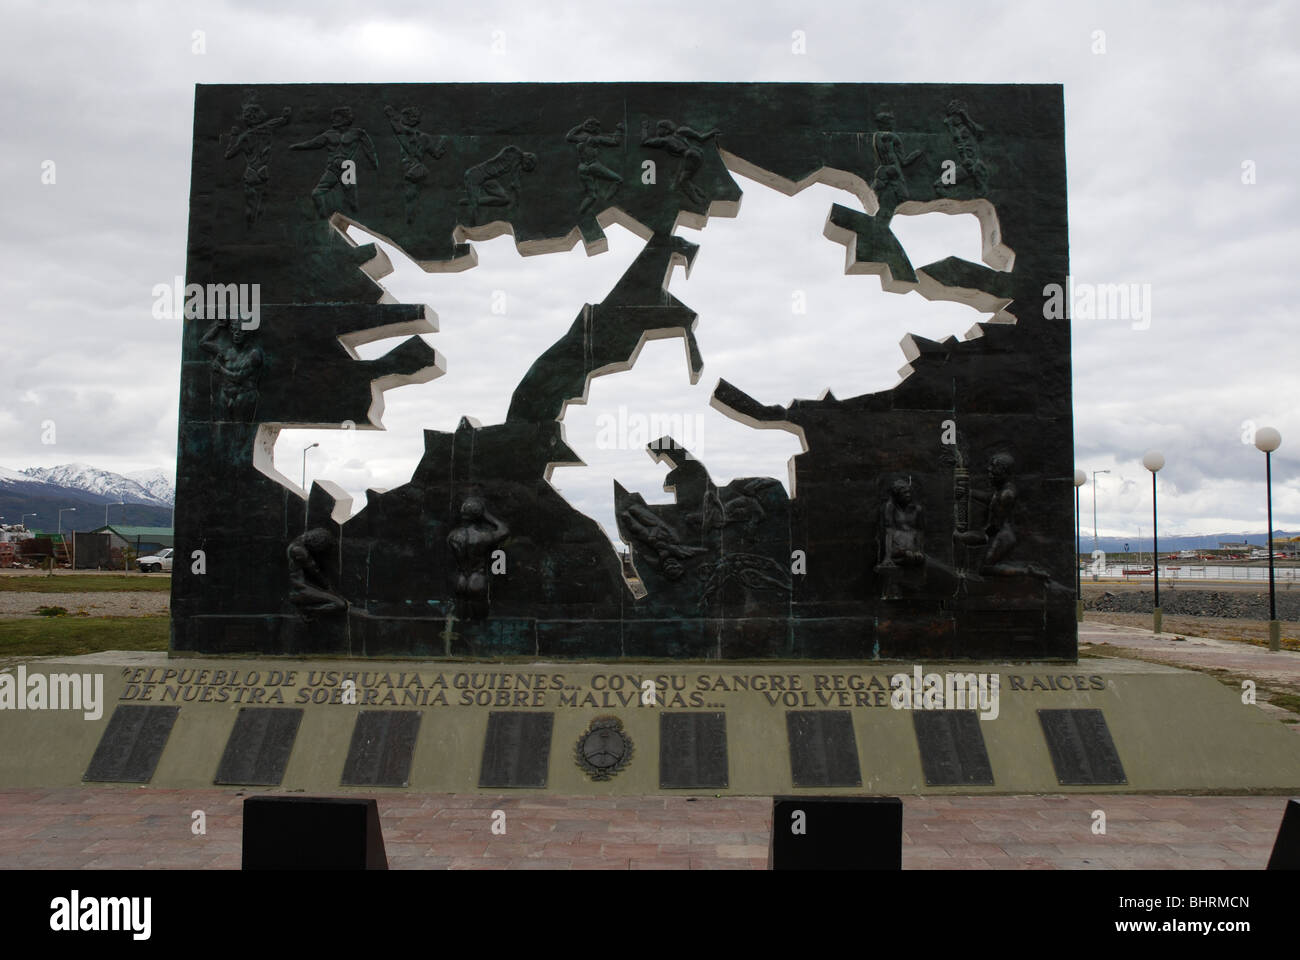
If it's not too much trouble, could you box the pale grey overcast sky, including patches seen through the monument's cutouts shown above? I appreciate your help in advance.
[0,0,1300,537]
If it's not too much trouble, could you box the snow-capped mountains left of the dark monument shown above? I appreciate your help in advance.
[0,463,176,532]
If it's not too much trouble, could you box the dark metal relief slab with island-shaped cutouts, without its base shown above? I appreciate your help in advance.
[172,83,1075,660]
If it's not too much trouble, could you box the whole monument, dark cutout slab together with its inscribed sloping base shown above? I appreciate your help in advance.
[0,83,1300,806]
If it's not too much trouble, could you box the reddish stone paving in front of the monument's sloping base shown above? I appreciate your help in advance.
[0,787,1283,869]
